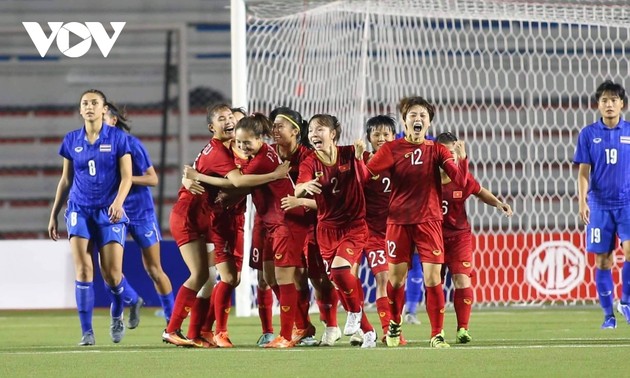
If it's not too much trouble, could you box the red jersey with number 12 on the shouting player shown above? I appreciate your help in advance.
[367,138,468,225]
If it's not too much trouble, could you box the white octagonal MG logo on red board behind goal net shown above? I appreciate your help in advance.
[526,241,586,295]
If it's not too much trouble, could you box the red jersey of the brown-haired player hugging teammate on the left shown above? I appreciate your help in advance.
[237,143,304,226]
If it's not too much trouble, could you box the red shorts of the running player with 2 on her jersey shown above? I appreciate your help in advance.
[317,219,369,276]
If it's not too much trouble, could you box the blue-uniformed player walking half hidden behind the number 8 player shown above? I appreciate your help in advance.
[104,102,175,329]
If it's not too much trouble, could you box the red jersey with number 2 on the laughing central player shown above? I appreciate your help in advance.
[298,146,367,228]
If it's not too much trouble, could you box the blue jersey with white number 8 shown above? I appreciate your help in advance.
[59,124,131,209]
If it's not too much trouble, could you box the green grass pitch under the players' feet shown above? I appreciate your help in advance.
[0,307,630,377]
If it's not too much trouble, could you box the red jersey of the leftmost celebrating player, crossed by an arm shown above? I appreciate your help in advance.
[178,138,236,206]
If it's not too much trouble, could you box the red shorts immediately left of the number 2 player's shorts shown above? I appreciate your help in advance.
[268,224,306,268]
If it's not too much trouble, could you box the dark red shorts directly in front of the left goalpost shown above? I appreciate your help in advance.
[210,212,245,272]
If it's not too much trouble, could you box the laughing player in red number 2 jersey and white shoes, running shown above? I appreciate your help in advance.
[295,114,376,348]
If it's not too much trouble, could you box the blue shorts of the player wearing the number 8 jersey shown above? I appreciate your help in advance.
[65,201,129,249]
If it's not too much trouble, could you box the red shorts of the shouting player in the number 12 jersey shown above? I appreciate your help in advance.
[385,221,444,264]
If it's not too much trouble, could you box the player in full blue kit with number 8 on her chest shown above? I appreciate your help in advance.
[48,89,132,346]
